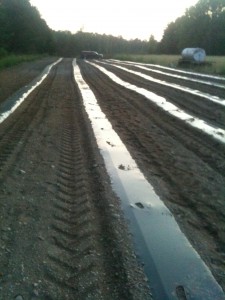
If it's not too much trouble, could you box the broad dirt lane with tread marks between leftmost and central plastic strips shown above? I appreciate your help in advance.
[0,59,151,300]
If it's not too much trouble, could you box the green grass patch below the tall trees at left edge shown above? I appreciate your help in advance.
[0,54,43,70]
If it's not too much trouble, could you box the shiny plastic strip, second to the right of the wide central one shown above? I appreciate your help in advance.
[103,63,225,106]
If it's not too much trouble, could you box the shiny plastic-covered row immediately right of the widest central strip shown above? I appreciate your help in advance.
[88,62,225,143]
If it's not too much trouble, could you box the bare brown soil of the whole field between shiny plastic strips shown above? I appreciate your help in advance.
[0,58,225,300]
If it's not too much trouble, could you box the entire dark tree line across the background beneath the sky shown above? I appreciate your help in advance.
[0,0,225,57]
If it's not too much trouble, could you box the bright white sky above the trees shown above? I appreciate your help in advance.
[30,0,198,41]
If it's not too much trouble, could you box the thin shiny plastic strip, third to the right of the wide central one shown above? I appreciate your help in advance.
[111,61,225,89]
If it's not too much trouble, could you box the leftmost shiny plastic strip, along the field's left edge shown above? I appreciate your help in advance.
[0,58,62,123]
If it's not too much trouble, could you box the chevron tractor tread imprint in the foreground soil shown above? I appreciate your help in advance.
[47,112,102,299]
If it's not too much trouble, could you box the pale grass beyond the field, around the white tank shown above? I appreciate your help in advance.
[113,54,225,76]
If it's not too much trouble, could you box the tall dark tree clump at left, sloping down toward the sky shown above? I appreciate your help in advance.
[0,0,52,54]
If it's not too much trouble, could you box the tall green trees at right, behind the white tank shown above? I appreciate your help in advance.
[160,0,225,55]
